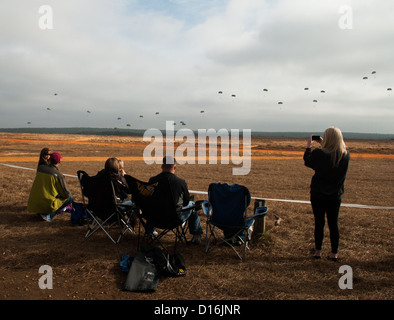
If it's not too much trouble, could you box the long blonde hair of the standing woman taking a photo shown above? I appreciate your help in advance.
[322,127,346,168]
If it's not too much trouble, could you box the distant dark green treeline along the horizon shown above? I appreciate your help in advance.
[0,127,394,140]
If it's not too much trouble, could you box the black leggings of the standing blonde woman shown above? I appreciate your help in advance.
[311,197,341,254]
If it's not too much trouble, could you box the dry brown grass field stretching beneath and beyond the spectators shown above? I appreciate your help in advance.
[0,133,394,300]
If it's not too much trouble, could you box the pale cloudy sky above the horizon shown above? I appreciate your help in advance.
[0,0,394,133]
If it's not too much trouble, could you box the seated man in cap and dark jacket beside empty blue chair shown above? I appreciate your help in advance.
[146,157,203,244]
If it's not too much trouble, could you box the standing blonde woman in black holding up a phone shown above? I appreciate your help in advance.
[304,127,350,261]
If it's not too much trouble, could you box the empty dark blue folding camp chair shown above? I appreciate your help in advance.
[203,183,268,261]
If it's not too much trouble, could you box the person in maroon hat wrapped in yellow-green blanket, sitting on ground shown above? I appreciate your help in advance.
[27,152,74,221]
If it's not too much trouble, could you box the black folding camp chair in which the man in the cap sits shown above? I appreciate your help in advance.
[125,175,197,254]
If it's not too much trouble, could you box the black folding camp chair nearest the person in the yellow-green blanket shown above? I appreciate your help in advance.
[77,170,135,244]
